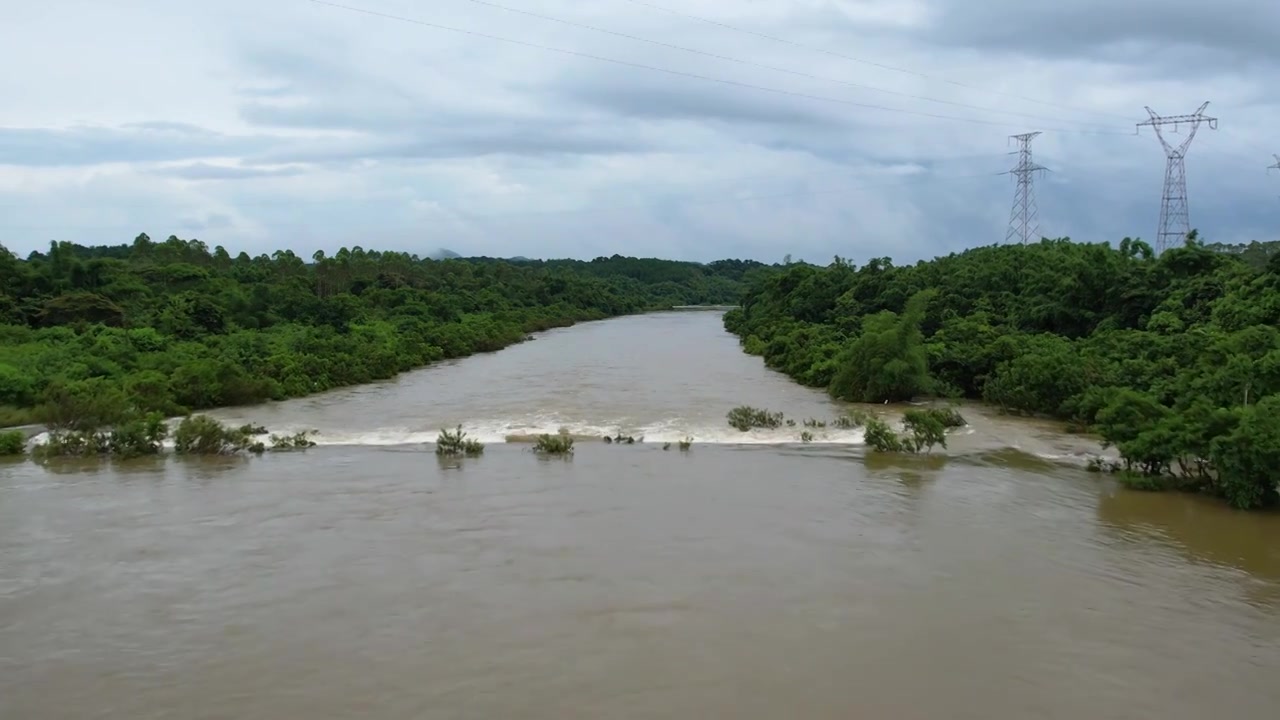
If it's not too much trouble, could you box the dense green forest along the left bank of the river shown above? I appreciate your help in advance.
[0,234,763,427]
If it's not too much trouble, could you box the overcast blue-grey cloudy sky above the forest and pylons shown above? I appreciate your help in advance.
[0,0,1280,261]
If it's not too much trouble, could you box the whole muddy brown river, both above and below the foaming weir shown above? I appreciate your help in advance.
[0,313,1280,720]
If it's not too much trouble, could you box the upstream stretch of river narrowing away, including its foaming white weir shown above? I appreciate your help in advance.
[5,311,1102,466]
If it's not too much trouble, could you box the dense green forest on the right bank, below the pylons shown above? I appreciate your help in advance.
[724,233,1280,509]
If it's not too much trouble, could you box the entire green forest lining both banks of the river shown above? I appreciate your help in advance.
[0,233,1280,509]
